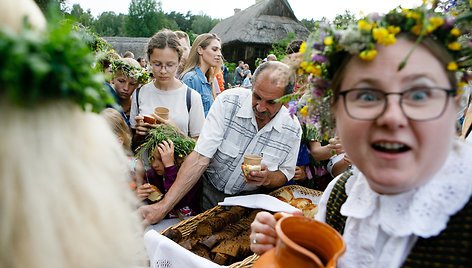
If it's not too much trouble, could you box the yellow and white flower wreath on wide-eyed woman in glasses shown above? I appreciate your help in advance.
[299,5,472,88]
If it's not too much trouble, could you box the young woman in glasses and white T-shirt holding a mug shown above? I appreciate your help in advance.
[130,29,205,146]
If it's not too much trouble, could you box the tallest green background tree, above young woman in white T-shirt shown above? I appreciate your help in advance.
[125,0,168,37]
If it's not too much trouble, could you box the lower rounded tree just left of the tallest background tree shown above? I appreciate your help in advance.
[93,11,126,36]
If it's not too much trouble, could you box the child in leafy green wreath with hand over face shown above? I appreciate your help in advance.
[136,125,199,218]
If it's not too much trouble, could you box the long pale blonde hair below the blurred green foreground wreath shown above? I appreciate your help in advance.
[0,100,144,268]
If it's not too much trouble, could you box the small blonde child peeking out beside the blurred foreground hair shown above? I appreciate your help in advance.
[101,108,145,191]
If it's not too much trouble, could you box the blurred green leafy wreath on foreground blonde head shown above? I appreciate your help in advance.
[0,19,114,112]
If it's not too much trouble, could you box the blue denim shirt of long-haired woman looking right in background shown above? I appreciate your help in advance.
[182,66,213,117]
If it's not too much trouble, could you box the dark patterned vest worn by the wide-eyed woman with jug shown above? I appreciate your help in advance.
[326,171,472,267]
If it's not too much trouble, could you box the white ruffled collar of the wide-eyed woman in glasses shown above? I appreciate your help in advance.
[341,139,472,238]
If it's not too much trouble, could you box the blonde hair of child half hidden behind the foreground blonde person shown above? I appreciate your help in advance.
[100,108,133,155]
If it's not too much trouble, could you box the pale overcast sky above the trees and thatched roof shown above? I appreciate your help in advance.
[67,0,422,20]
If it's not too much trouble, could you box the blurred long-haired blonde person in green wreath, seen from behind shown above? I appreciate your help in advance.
[0,0,145,268]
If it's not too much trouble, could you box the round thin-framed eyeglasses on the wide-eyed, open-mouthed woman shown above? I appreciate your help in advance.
[339,87,456,121]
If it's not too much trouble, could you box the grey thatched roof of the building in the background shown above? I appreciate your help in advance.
[210,0,310,44]
